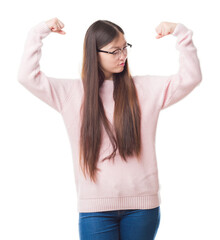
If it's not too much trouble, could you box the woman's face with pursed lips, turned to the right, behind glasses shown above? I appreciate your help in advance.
[98,32,127,80]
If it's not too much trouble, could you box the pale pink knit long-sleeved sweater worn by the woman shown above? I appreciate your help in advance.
[18,21,202,212]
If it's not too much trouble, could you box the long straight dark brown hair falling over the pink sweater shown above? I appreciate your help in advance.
[79,20,141,182]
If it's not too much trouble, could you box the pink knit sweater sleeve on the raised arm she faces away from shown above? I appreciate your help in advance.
[17,21,74,112]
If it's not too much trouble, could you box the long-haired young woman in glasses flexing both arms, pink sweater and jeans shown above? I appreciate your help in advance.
[18,18,202,240]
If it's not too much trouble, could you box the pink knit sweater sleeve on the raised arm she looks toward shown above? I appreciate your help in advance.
[161,23,202,110]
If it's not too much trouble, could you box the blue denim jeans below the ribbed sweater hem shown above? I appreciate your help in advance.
[79,206,160,240]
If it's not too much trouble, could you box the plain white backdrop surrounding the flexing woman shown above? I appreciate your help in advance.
[0,0,220,240]
